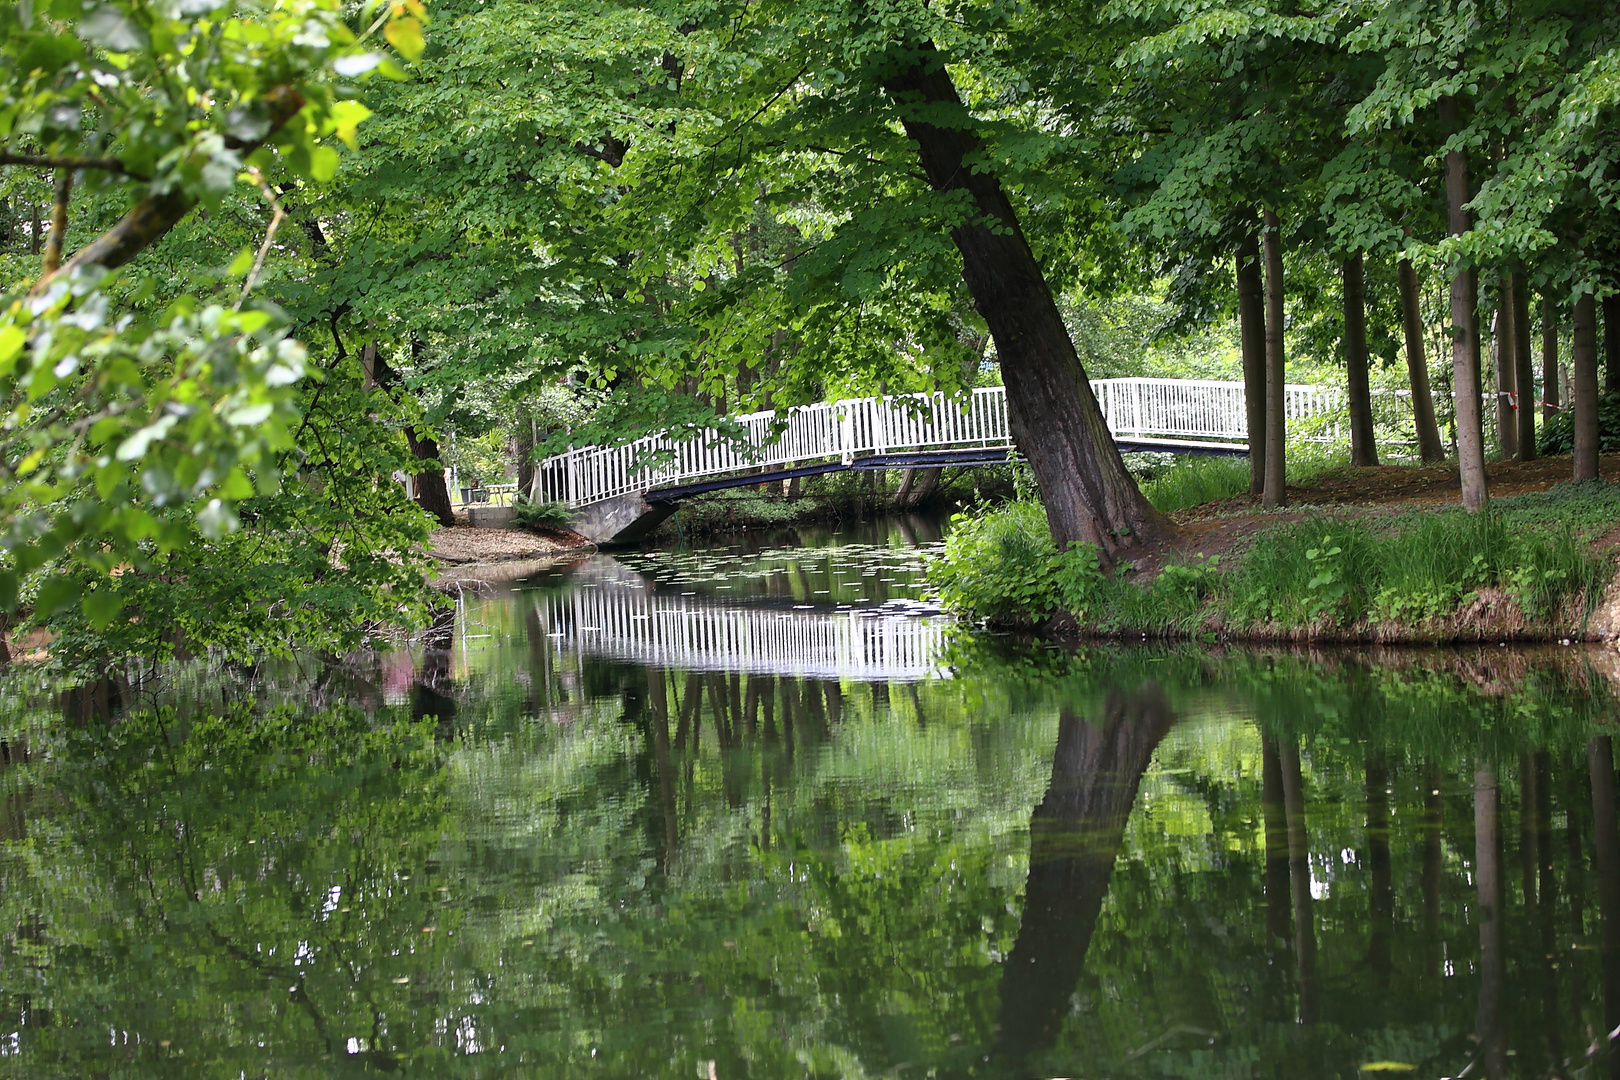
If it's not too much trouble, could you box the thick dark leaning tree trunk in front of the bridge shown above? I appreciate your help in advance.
[885,42,1173,562]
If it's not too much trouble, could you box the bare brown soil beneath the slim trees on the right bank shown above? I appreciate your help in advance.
[1136,453,1620,575]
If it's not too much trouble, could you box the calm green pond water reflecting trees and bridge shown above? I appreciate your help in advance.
[0,529,1620,1080]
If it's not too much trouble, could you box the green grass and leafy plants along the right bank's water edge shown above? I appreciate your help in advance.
[930,481,1620,641]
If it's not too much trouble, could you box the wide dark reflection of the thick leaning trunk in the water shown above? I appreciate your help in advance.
[996,683,1173,1062]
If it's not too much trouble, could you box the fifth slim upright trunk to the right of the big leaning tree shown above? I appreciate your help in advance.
[1440,97,1490,510]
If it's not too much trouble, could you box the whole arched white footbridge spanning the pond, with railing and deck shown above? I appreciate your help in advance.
[531,379,1343,542]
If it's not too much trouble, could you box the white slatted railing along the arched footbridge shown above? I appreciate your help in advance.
[530,379,1343,507]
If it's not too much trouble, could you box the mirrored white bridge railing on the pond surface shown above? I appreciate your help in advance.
[524,557,949,682]
